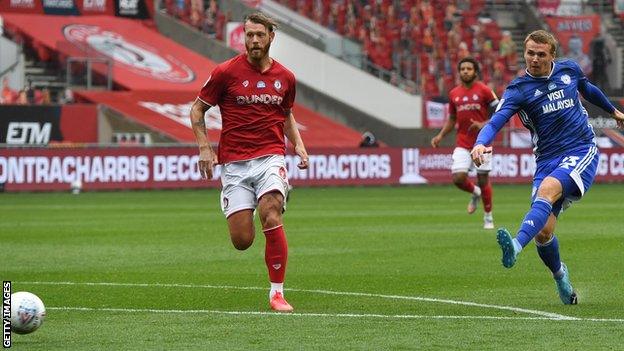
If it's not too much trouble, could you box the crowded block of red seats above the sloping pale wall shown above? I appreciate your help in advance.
[270,0,517,96]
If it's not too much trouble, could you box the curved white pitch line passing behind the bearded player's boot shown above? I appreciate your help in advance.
[21,282,579,320]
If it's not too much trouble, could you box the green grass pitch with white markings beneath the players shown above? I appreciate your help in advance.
[0,184,624,350]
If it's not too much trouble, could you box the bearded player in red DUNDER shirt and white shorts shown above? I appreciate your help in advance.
[191,13,308,312]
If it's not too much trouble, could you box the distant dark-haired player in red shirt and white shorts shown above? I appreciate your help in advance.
[431,57,498,229]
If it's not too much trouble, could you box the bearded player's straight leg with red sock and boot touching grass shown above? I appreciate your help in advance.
[258,191,293,312]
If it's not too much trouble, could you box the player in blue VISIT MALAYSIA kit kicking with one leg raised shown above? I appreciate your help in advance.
[471,30,624,305]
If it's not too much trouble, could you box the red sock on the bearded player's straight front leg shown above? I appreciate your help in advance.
[264,225,288,283]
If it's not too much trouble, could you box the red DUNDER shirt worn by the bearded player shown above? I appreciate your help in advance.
[198,53,295,163]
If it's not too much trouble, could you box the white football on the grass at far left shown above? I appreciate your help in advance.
[11,291,45,334]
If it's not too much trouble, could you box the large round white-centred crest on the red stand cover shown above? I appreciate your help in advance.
[63,24,195,83]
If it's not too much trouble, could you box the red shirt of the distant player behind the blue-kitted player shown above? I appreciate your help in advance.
[449,81,498,149]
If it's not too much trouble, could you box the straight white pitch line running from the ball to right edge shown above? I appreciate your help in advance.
[47,306,624,323]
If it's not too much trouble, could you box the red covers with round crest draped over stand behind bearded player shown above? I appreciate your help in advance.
[3,8,361,147]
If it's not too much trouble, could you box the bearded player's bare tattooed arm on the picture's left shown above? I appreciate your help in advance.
[191,99,218,179]
